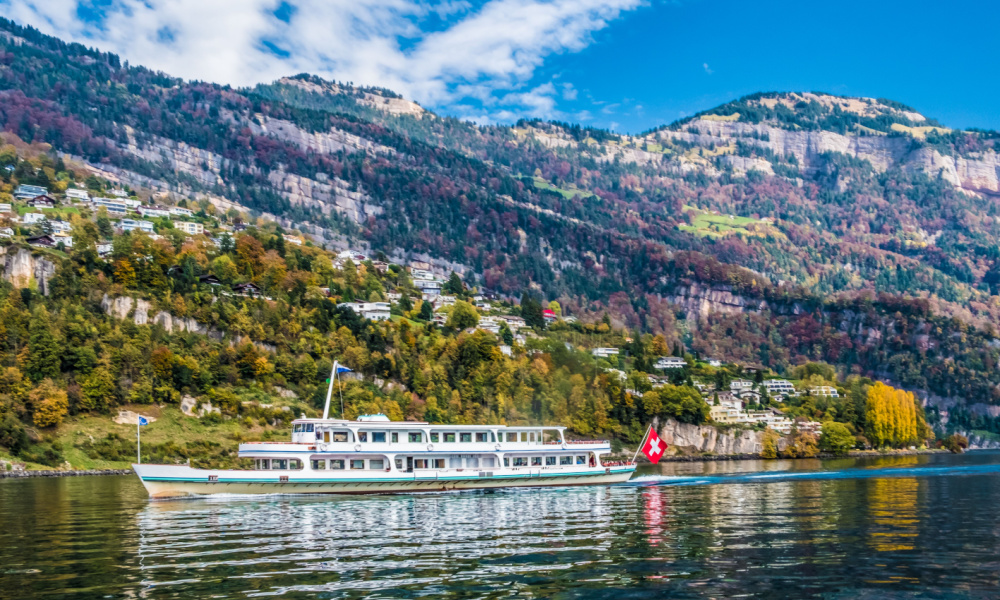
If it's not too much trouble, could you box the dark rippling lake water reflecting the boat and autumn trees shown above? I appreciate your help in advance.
[0,452,1000,600]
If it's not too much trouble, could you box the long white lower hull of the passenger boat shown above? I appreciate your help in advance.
[132,465,635,498]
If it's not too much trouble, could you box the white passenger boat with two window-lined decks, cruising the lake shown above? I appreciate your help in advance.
[133,415,635,498]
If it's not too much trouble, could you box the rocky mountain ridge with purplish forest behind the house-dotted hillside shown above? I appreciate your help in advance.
[0,16,1000,432]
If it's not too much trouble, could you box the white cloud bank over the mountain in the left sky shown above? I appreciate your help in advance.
[0,0,643,116]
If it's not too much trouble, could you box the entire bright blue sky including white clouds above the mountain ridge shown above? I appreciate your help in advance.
[0,0,1000,132]
